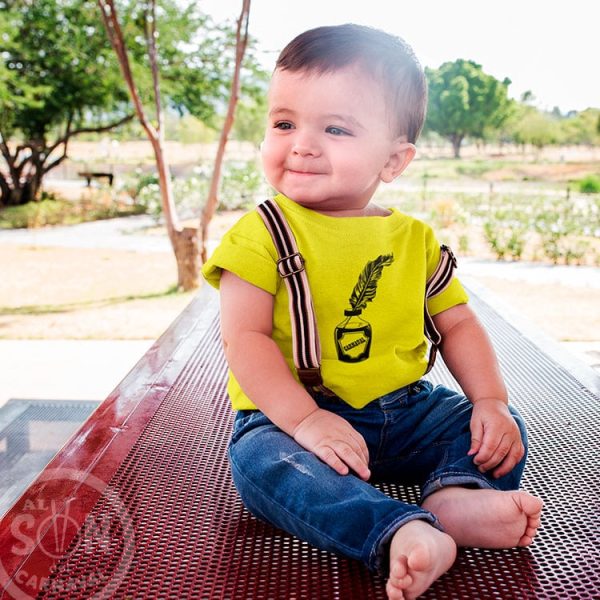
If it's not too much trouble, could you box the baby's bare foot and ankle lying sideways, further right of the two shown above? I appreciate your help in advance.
[423,487,543,548]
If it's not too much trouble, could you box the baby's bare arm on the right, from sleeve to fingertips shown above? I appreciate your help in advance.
[433,304,525,477]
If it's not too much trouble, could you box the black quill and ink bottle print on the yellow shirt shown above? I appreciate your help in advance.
[335,254,394,363]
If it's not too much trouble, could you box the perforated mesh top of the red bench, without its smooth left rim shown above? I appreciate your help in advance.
[1,288,600,600]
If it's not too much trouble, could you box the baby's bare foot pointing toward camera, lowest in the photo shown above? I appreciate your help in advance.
[386,520,456,600]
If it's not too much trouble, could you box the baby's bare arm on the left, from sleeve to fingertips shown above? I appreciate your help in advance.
[220,271,370,480]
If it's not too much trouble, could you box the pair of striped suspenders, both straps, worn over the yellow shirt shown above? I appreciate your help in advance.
[257,200,456,384]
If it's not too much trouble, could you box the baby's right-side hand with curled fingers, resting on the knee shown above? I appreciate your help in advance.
[468,398,525,478]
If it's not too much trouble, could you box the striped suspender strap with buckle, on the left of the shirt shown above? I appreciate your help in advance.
[257,200,329,393]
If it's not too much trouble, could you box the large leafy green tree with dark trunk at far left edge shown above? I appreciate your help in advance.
[0,0,133,205]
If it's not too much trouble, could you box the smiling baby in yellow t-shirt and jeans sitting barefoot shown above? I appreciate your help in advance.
[203,25,542,599]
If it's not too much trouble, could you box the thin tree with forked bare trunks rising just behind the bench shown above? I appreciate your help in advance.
[97,0,250,290]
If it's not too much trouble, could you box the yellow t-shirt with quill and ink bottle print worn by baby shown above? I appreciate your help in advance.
[202,194,468,410]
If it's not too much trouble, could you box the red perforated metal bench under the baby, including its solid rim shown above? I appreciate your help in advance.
[0,286,600,600]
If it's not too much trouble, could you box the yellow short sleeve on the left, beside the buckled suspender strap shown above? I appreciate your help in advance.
[202,211,278,294]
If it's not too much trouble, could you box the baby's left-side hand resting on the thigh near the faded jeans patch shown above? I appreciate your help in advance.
[292,408,371,481]
